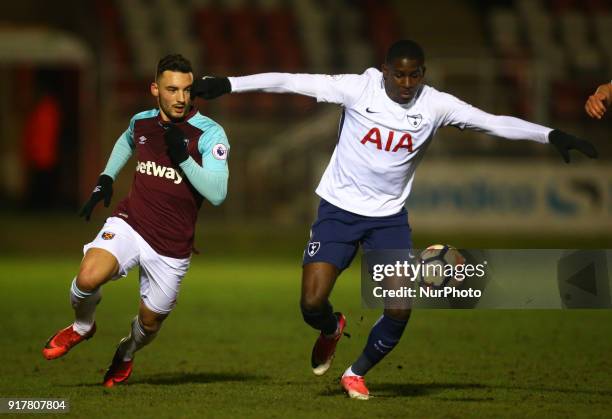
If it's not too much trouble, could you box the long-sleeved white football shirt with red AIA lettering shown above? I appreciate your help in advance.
[229,68,552,217]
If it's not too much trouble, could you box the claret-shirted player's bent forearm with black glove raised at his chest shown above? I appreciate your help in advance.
[164,125,229,205]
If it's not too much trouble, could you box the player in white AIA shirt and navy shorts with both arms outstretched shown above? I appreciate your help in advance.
[192,40,597,399]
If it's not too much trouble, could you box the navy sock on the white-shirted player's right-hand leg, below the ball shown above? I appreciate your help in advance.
[351,316,408,375]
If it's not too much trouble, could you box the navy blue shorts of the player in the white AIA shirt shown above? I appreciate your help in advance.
[303,199,412,271]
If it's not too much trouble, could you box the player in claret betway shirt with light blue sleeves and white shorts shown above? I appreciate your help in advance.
[42,55,229,387]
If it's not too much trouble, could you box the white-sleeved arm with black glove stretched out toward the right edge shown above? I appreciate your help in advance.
[445,95,597,163]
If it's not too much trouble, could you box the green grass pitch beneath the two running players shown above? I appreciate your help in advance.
[0,255,612,418]
